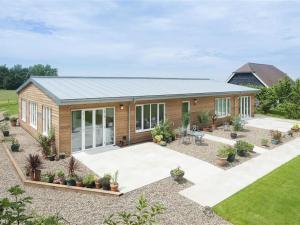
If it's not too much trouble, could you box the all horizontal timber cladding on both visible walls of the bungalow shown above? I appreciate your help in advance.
[19,81,255,154]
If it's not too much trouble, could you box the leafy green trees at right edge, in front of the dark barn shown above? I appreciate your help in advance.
[256,78,300,119]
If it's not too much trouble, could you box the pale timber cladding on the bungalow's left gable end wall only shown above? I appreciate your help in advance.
[18,84,59,149]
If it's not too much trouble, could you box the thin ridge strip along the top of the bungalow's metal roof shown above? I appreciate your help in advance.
[30,76,210,80]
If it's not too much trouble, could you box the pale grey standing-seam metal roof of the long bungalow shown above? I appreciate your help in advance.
[17,77,259,105]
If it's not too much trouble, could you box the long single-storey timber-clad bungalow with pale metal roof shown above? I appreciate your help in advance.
[17,77,258,154]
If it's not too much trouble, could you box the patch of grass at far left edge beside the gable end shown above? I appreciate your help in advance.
[0,89,18,115]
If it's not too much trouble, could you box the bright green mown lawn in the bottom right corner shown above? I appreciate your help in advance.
[213,157,300,225]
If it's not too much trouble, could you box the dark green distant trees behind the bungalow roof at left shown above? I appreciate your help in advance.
[0,64,57,90]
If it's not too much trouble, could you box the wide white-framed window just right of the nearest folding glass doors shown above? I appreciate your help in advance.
[135,103,165,131]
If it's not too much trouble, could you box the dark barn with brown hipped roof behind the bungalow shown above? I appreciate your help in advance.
[227,63,290,87]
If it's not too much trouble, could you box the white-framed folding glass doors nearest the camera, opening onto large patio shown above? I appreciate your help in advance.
[72,108,115,152]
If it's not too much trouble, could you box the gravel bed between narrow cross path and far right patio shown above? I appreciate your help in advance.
[209,126,300,149]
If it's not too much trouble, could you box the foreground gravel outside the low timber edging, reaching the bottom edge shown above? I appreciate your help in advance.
[0,145,230,225]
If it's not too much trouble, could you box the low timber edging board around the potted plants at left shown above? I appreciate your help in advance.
[1,143,123,197]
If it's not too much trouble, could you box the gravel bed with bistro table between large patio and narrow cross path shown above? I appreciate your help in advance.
[167,140,259,170]
